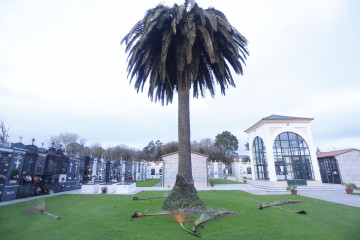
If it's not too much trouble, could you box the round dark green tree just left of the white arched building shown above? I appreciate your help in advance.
[215,131,239,163]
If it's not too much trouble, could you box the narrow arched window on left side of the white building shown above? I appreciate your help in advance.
[253,137,269,180]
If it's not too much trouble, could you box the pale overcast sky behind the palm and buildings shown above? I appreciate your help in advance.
[0,0,360,154]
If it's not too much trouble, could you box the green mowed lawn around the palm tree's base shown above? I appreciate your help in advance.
[0,191,360,240]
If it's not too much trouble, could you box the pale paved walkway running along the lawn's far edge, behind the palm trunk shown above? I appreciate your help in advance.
[0,181,360,207]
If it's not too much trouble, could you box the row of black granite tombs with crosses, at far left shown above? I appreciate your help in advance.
[0,142,85,201]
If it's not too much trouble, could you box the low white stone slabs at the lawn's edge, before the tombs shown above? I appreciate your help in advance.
[81,183,136,194]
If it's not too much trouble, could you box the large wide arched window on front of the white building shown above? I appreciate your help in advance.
[273,132,314,185]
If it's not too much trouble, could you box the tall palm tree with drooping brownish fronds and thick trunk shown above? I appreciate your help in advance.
[121,0,248,209]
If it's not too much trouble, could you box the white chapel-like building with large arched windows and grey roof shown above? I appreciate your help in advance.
[245,115,322,186]
